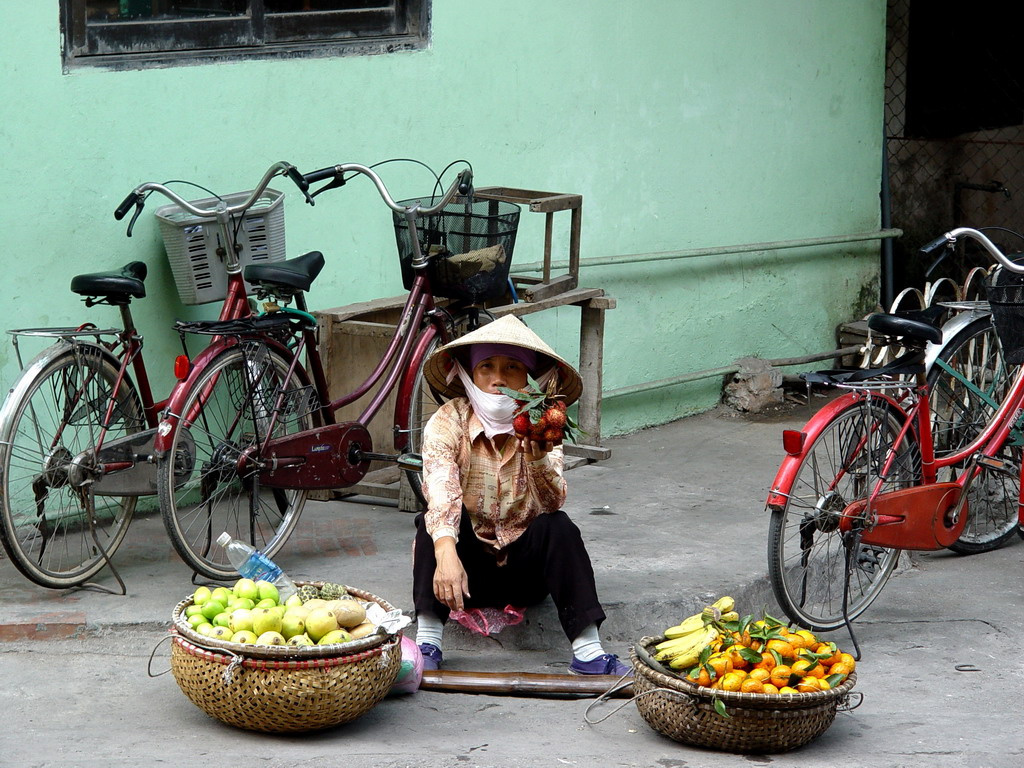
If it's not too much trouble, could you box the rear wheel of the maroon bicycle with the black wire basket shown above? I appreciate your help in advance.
[157,341,312,581]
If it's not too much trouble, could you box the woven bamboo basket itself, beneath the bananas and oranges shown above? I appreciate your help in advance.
[630,637,857,754]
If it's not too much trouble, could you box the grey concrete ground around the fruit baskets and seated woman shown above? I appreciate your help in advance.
[0,401,1024,768]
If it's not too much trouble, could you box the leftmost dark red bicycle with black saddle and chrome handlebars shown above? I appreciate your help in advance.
[0,163,305,594]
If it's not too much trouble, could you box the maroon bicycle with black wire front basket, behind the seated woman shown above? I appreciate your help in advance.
[149,159,519,580]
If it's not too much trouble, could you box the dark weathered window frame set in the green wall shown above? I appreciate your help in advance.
[60,0,432,71]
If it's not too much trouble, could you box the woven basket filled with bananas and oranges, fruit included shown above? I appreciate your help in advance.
[631,597,857,754]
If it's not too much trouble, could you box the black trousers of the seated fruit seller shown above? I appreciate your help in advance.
[413,510,605,641]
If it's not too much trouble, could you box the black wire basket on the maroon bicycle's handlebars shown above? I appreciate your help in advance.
[394,197,519,303]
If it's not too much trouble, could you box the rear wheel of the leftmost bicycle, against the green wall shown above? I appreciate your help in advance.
[0,342,144,589]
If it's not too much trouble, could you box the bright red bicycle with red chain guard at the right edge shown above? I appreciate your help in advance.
[767,227,1024,631]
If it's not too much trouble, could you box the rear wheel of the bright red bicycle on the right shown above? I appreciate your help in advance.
[768,399,921,632]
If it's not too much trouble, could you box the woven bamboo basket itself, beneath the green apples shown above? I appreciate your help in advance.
[171,589,401,733]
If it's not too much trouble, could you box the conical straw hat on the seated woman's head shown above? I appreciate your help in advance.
[423,314,583,406]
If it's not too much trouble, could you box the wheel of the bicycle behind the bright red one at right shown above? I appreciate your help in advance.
[928,315,1021,555]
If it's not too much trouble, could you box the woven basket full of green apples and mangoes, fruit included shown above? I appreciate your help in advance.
[171,579,408,732]
